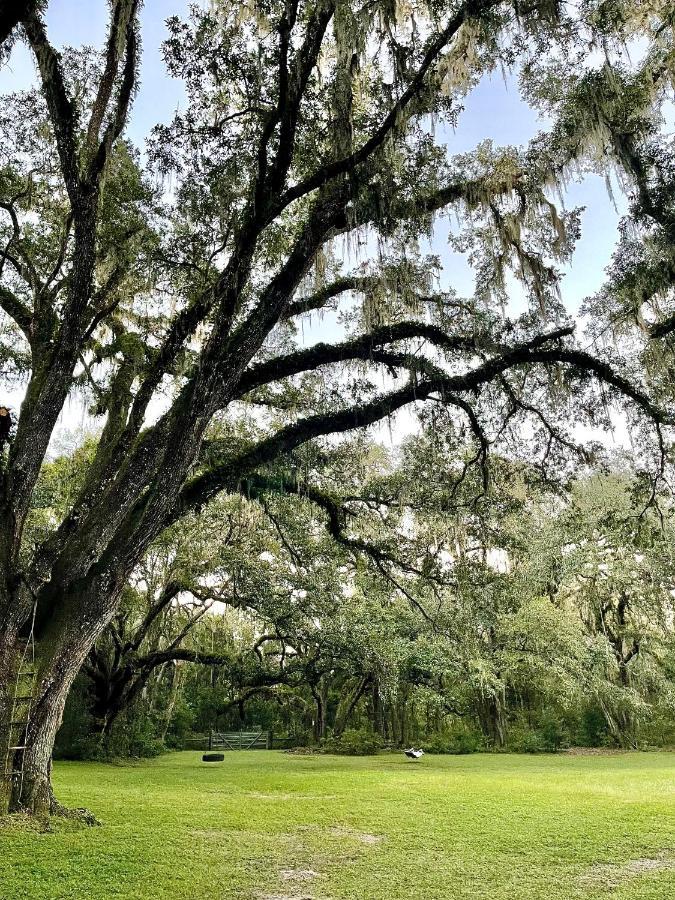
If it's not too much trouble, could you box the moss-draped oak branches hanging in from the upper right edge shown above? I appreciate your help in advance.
[548,0,675,394]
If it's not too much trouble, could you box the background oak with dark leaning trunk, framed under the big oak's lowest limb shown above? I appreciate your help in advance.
[83,488,365,738]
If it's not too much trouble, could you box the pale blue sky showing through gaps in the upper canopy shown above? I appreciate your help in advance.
[0,0,623,320]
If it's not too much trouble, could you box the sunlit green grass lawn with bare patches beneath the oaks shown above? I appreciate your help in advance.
[0,751,675,900]
